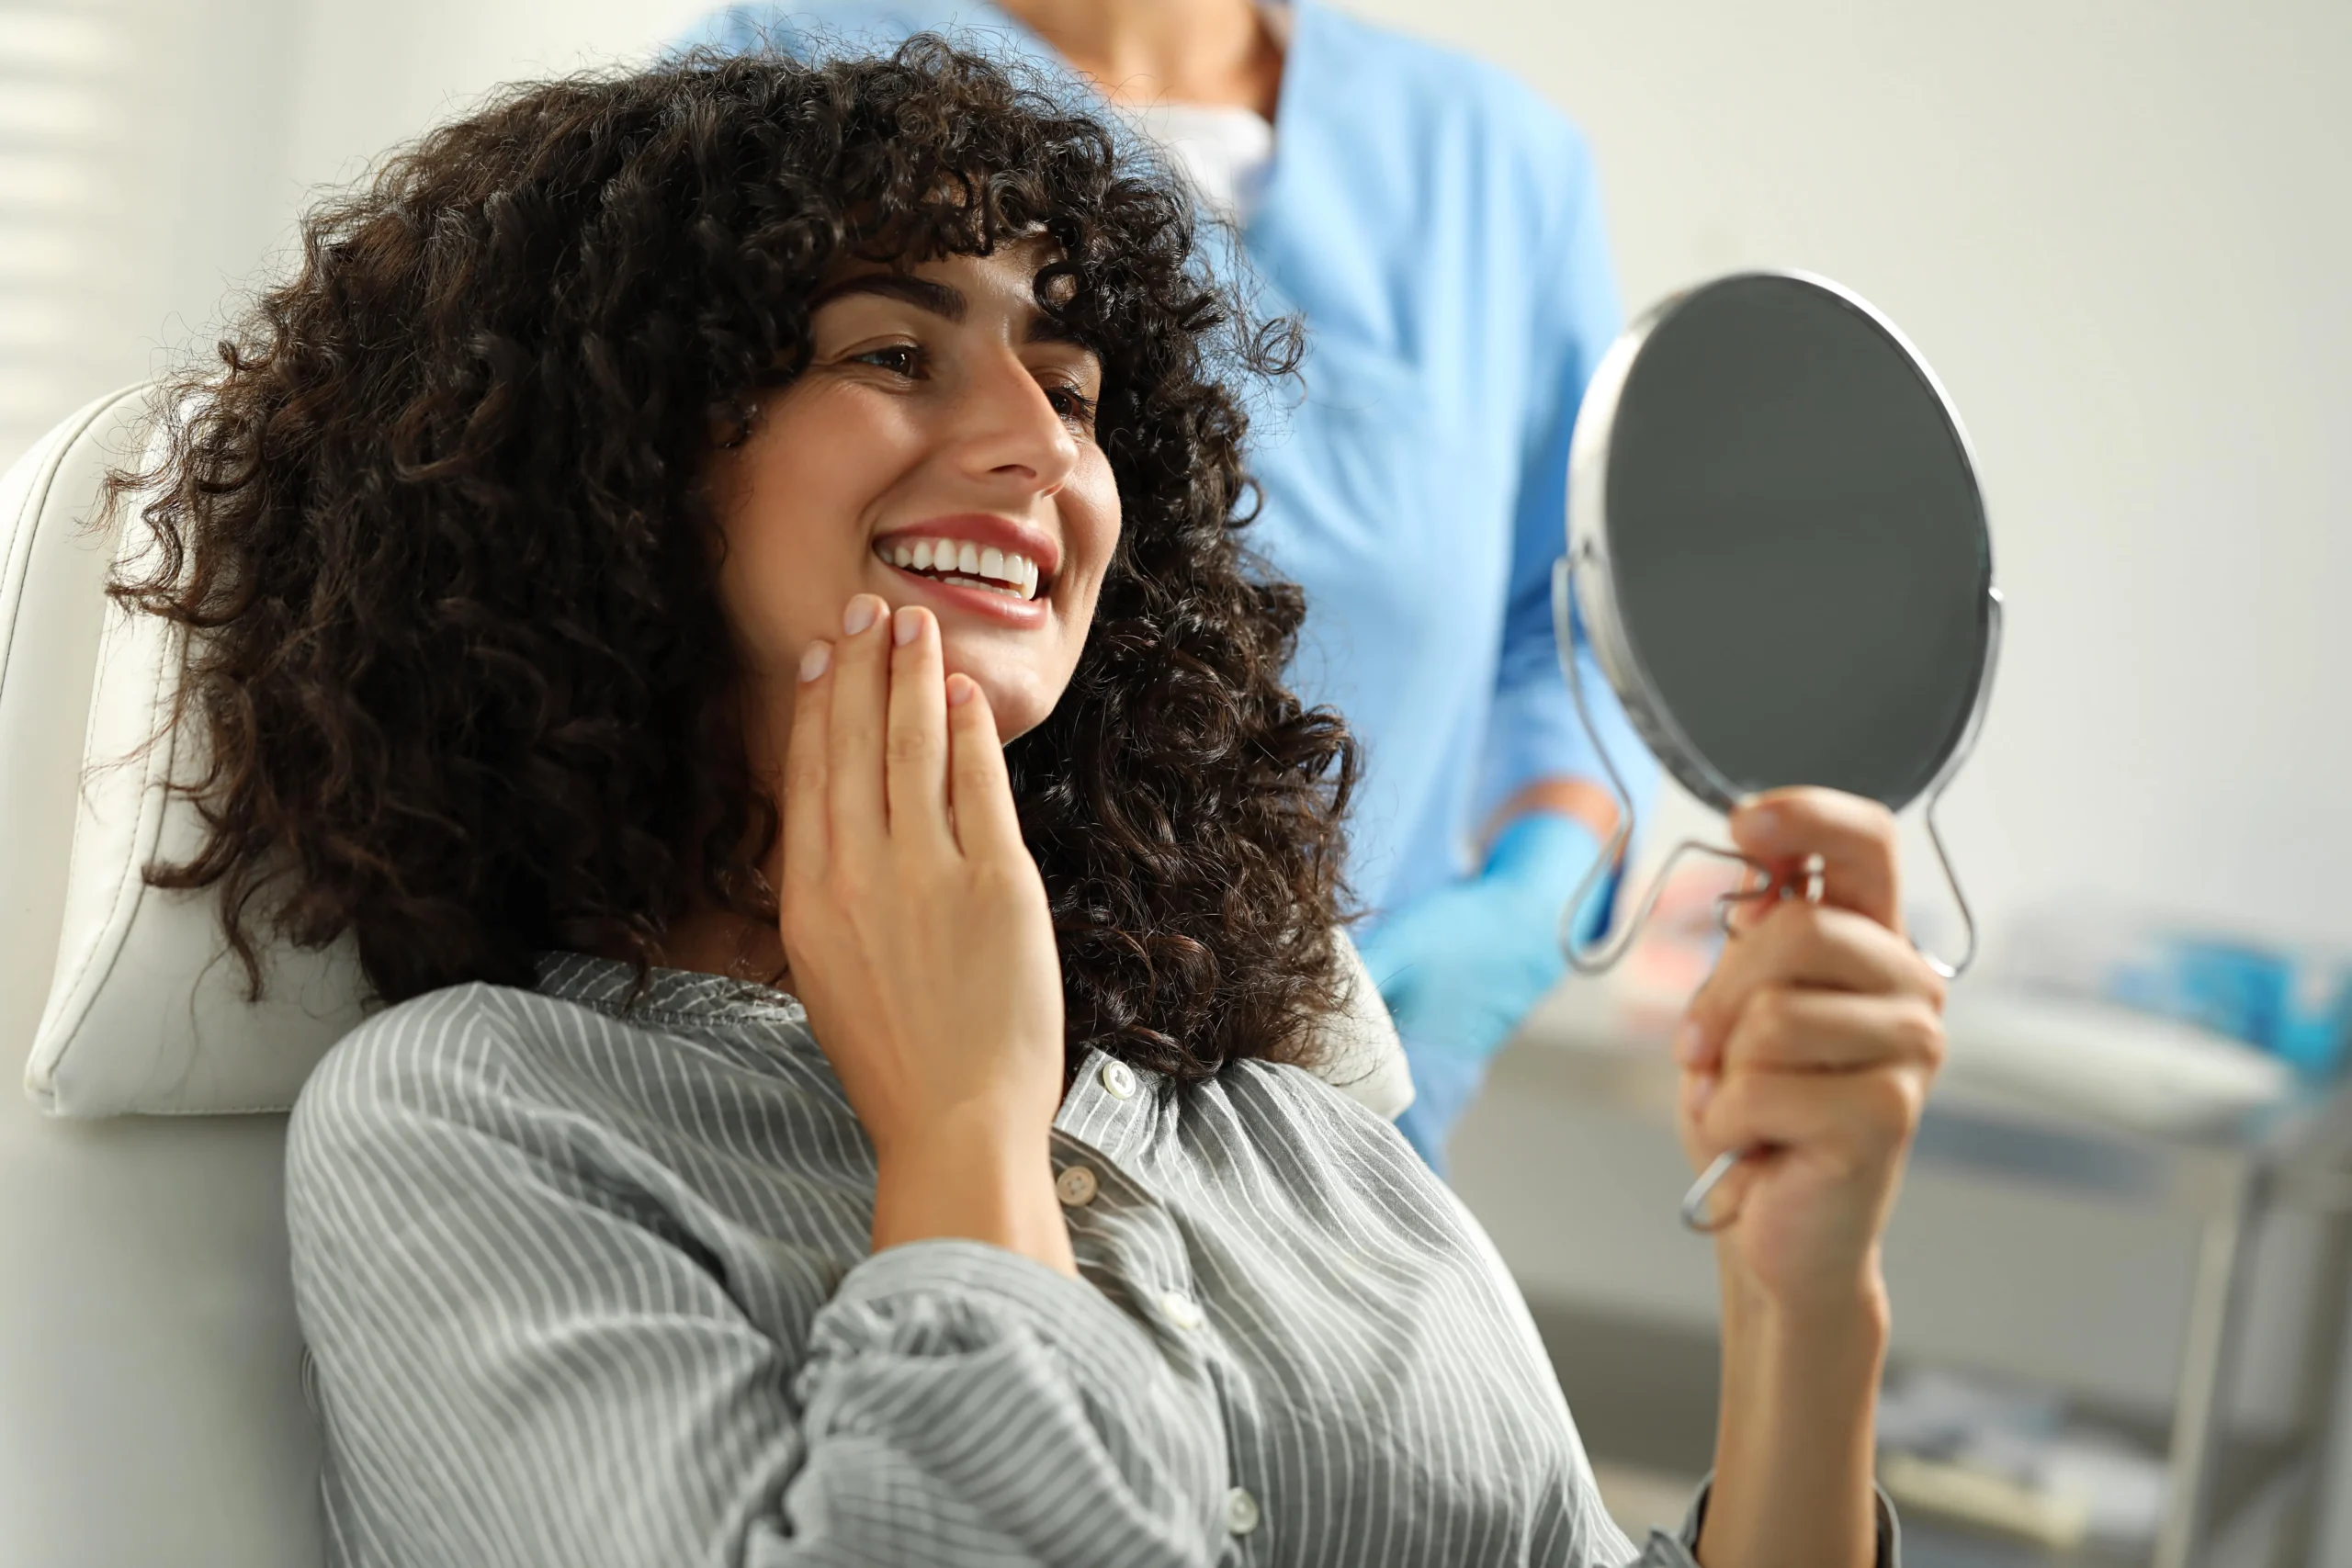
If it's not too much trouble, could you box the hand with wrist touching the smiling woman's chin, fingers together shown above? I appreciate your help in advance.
[781,594,1075,1274]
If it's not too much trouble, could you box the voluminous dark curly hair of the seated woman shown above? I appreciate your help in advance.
[113,38,1355,1079]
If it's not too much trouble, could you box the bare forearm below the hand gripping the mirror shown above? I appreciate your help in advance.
[1698,1256,1886,1568]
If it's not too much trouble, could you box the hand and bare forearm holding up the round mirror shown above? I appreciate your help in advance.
[1677,790,1945,1568]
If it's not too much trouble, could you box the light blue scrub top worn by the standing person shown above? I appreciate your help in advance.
[689,0,1656,912]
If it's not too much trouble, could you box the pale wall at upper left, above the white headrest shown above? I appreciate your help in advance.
[0,0,706,463]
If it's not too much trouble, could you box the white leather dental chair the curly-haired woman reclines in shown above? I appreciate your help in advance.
[0,386,1411,1568]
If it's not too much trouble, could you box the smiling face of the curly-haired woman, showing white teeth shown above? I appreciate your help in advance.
[713,243,1120,743]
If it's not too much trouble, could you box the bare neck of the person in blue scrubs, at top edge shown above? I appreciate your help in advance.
[997,0,1282,120]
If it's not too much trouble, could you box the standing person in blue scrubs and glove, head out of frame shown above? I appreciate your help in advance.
[689,0,1656,1166]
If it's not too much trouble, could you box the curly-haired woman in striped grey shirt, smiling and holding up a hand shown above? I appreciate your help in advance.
[122,45,1938,1568]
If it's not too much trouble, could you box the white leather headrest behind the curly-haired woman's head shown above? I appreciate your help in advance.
[0,388,1411,1117]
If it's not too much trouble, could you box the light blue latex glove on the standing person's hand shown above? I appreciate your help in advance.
[1360,811,1616,1170]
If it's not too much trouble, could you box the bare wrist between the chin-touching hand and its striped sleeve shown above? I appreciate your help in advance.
[873,1119,1077,1279]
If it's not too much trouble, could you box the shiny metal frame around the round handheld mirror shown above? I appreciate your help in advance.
[1553,268,2002,980]
